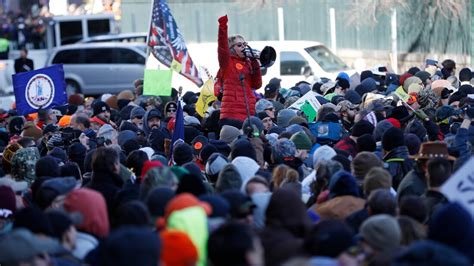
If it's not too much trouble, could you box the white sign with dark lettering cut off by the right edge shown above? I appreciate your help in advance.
[441,157,474,217]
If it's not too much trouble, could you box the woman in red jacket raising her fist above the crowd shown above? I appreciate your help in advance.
[214,15,262,129]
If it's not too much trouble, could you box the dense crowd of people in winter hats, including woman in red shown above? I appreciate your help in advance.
[0,18,474,266]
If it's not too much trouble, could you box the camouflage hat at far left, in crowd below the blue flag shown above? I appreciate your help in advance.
[12,147,40,184]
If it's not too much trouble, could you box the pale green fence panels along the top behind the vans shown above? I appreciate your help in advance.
[122,0,474,55]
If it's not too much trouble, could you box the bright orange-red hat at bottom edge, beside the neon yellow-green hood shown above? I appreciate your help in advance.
[160,230,199,266]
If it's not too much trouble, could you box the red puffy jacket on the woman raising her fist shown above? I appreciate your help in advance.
[217,16,262,121]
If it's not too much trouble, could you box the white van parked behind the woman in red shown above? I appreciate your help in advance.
[147,41,355,92]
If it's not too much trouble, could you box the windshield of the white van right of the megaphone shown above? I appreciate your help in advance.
[305,45,349,72]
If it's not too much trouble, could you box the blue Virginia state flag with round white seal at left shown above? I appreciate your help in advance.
[13,65,67,115]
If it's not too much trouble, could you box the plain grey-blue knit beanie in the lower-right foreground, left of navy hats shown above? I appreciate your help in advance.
[360,214,402,252]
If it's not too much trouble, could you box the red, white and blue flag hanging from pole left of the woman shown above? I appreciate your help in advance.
[148,0,203,87]
